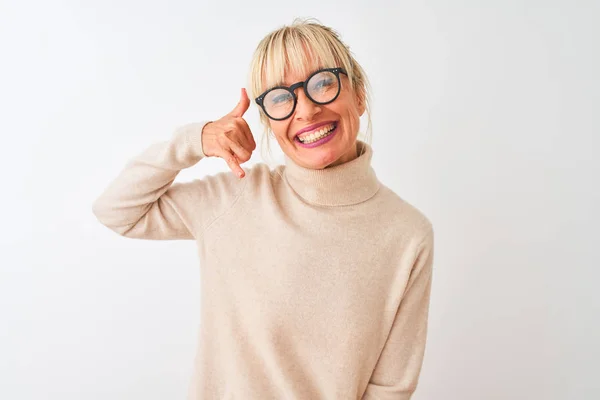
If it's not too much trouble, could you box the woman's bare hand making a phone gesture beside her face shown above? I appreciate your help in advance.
[202,88,256,178]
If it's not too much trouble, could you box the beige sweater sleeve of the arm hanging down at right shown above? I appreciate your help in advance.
[362,227,434,400]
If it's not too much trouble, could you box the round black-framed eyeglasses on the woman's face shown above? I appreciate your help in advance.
[255,67,348,121]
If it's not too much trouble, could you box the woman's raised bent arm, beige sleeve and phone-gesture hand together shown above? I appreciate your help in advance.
[92,90,256,240]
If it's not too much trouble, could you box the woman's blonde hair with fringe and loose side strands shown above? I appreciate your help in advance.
[248,18,372,161]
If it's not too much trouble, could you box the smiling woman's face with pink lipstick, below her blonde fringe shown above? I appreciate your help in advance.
[269,68,365,169]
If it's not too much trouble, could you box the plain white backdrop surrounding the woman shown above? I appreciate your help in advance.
[0,0,600,400]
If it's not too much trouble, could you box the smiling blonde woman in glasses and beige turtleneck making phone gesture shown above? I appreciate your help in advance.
[93,21,433,400]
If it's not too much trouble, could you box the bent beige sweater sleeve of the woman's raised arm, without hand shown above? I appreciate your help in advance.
[92,121,245,240]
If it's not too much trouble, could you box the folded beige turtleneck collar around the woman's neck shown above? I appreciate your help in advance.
[284,140,379,206]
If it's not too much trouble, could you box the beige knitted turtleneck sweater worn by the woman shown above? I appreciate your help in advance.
[93,123,433,400]
